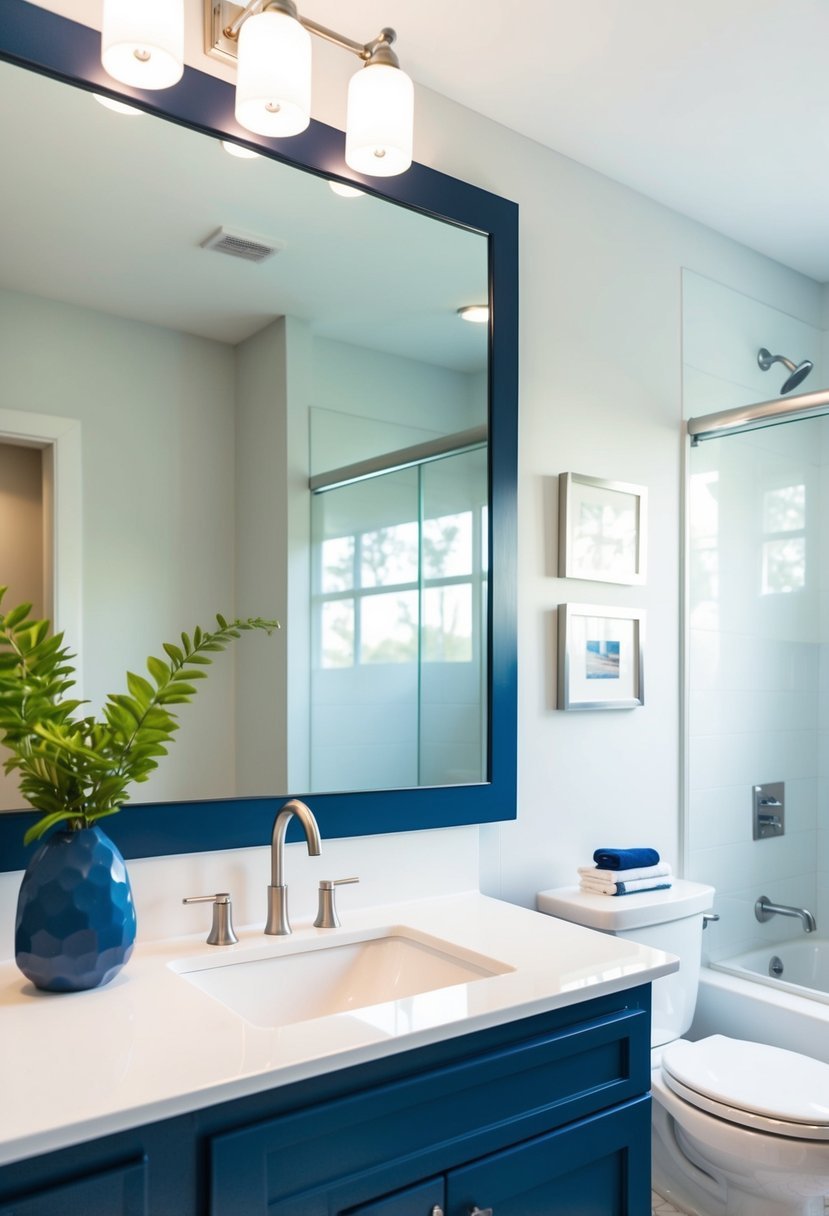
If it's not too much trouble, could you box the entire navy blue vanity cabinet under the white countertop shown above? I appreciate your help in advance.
[0,985,650,1216]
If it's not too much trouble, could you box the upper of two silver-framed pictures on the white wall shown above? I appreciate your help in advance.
[558,473,648,585]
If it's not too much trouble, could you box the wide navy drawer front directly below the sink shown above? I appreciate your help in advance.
[210,1008,650,1216]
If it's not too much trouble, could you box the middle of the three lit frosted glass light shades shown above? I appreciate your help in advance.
[236,12,311,137]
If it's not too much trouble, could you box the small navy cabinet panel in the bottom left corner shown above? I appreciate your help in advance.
[0,1161,147,1216]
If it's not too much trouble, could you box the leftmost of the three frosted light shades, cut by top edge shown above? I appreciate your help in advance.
[101,0,185,89]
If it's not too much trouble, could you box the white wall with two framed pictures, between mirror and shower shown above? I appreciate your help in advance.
[9,0,819,933]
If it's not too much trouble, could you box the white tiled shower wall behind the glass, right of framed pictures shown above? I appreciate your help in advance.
[683,272,829,957]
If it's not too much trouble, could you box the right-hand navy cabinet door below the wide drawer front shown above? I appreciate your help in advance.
[446,1098,650,1216]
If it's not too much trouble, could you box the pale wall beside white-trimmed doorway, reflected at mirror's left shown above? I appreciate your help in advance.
[0,291,235,801]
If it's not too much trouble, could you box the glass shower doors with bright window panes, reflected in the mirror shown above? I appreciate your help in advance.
[309,445,487,790]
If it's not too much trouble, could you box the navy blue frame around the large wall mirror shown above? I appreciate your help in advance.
[0,0,518,871]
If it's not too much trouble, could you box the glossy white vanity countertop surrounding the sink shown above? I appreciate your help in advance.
[0,893,678,1165]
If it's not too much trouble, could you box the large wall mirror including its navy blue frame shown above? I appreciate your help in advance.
[0,0,517,868]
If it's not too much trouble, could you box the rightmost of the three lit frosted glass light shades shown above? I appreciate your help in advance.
[345,63,415,178]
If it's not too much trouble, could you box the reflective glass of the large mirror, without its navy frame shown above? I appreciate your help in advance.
[0,52,489,809]
